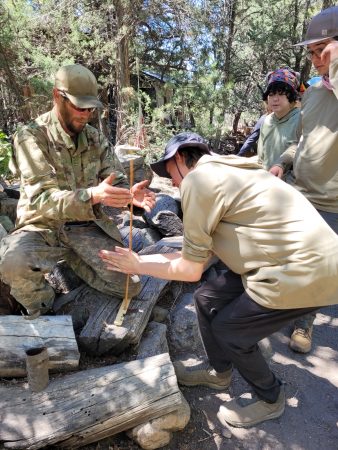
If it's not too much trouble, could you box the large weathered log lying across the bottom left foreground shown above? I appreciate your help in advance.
[0,353,182,450]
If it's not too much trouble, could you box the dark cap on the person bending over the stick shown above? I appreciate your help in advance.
[150,132,210,178]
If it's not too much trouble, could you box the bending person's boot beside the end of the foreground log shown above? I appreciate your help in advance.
[173,361,232,391]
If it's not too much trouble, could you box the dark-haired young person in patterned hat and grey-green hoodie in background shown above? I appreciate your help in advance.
[257,67,301,170]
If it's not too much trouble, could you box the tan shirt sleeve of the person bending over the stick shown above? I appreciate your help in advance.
[181,170,225,263]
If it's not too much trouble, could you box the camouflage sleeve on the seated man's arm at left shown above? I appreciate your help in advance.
[14,127,95,220]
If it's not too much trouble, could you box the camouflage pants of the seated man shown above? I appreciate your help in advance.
[0,223,140,315]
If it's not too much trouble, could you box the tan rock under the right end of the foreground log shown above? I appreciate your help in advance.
[127,395,190,450]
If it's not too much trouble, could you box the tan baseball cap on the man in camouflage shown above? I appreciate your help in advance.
[55,64,103,108]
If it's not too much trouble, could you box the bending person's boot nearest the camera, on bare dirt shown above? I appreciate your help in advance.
[217,386,285,427]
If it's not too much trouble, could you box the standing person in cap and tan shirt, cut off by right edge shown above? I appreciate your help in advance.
[270,6,338,353]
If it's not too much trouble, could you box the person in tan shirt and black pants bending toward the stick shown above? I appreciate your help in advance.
[100,133,338,427]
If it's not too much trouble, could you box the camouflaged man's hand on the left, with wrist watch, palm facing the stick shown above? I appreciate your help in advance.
[92,172,132,208]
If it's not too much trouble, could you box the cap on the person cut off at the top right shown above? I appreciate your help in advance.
[295,6,338,45]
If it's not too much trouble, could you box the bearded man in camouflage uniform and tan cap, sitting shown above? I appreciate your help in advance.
[0,64,155,317]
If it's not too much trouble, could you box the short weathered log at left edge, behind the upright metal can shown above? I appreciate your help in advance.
[0,316,80,377]
